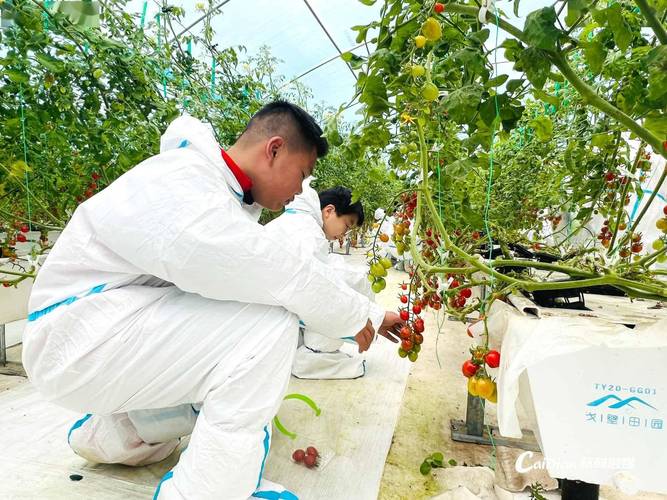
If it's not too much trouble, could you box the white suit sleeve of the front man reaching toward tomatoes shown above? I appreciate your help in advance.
[90,150,378,337]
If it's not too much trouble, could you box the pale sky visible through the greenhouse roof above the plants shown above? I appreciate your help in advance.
[126,0,553,121]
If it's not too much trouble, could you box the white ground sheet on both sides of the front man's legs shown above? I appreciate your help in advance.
[0,324,411,500]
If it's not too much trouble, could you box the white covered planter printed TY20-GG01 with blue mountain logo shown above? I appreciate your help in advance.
[489,296,667,493]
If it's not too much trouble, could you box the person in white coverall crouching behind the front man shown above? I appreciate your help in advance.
[266,178,374,379]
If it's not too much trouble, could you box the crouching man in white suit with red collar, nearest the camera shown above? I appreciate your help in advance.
[23,101,400,500]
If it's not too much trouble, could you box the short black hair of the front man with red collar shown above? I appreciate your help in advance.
[239,101,329,158]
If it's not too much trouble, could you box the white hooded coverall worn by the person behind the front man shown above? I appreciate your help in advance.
[266,178,374,379]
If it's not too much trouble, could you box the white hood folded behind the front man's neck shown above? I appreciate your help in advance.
[160,113,262,218]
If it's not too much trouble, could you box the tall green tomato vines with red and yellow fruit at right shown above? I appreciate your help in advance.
[346,0,667,370]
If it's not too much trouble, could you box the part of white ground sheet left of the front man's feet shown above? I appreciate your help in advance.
[0,375,169,500]
